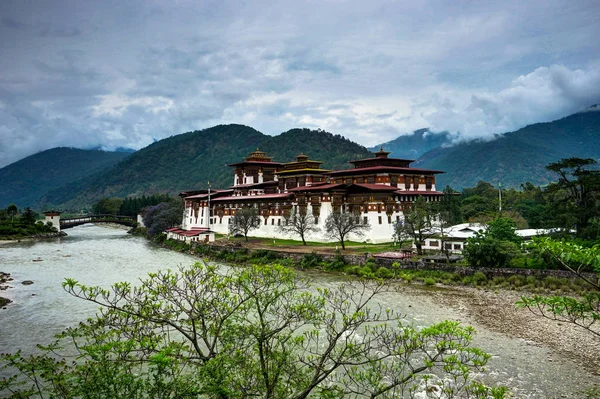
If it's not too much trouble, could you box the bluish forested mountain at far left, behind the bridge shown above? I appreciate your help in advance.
[0,147,130,208]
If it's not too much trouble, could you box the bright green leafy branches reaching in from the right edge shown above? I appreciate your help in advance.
[517,237,600,336]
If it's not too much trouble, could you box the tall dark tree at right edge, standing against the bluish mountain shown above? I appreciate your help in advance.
[546,158,600,238]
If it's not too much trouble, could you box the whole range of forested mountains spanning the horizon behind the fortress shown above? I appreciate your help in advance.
[0,106,600,210]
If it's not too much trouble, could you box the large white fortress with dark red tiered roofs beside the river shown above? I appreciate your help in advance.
[180,149,443,243]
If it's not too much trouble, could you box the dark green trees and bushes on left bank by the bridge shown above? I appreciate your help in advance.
[0,204,57,240]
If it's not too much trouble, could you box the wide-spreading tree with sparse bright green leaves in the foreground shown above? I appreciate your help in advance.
[0,264,505,399]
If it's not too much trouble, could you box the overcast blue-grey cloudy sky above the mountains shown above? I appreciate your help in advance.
[0,0,600,167]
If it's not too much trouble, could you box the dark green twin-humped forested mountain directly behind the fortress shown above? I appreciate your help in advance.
[43,125,370,209]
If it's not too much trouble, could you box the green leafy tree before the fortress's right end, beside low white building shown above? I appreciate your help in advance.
[393,197,439,255]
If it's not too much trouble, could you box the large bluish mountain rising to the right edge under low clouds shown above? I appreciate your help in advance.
[412,108,600,189]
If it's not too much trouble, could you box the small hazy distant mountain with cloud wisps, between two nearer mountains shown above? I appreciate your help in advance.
[369,129,450,159]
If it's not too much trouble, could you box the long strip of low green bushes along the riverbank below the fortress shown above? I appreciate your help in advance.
[155,239,590,295]
